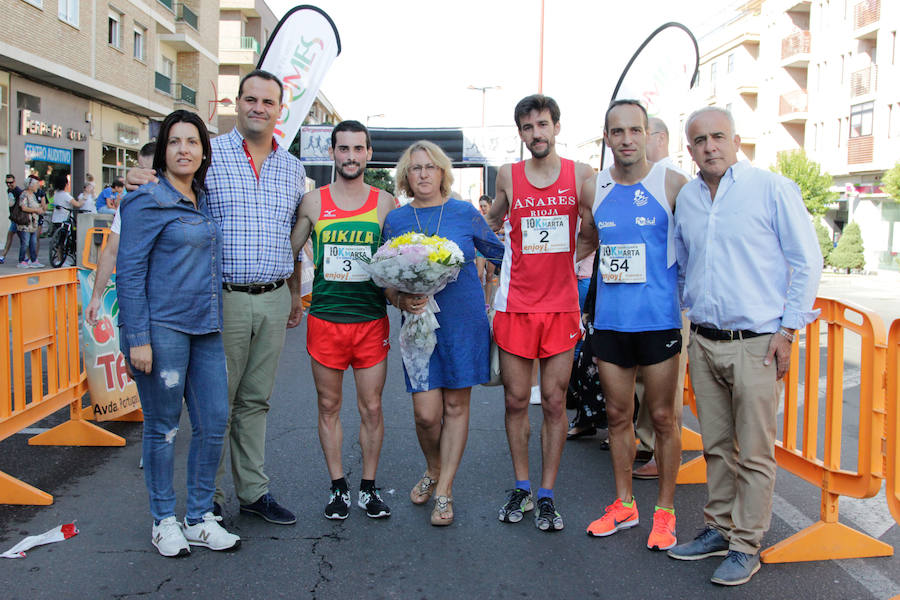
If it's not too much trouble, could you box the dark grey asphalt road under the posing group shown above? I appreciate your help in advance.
[0,304,900,600]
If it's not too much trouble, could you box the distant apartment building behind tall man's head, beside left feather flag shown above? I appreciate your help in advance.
[215,0,341,132]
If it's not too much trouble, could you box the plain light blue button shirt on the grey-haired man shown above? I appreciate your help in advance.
[675,161,822,333]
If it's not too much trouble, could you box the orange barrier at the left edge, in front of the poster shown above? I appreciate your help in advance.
[0,267,125,504]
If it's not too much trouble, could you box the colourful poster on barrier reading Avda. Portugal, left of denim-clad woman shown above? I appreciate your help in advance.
[78,269,141,421]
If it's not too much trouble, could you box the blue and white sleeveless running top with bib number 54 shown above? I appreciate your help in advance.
[594,163,681,332]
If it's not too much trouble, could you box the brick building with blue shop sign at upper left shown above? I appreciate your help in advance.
[0,0,218,226]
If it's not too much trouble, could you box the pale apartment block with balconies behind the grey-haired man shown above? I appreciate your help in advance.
[673,0,900,270]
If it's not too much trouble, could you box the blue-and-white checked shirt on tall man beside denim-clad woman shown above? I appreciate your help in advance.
[206,129,306,284]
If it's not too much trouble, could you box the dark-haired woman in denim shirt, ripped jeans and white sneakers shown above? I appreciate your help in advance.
[116,110,240,556]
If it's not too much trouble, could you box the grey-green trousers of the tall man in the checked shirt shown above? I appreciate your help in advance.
[214,285,291,505]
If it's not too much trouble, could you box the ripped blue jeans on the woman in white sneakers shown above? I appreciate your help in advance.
[132,323,228,521]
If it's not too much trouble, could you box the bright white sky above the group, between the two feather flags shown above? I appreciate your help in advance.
[267,0,740,147]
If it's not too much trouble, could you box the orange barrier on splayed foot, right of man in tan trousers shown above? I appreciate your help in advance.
[760,298,896,563]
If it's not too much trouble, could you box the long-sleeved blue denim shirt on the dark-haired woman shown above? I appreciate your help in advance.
[116,177,222,347]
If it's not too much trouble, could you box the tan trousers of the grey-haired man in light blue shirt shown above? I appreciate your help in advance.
[688,334,778,554]
